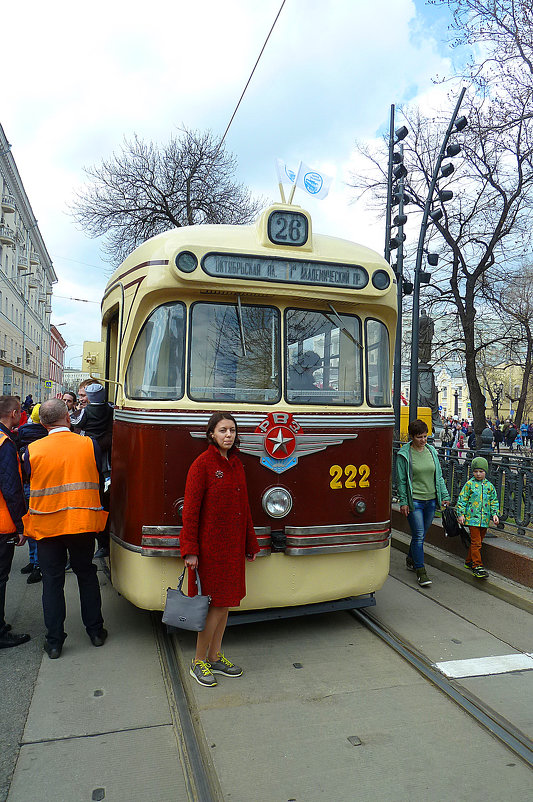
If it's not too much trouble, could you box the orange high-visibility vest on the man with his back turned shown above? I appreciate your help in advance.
[22,431,108,540]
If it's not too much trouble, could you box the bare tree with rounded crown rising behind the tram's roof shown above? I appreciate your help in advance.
[72,128,262,265]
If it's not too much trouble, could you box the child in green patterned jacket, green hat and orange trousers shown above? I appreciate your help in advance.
[456,457,500,579]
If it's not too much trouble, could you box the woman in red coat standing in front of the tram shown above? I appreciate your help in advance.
[180,412,259,687]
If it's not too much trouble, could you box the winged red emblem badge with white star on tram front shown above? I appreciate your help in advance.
[239,412,357,473]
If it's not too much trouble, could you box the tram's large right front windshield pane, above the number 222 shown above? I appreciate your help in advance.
[285,309,363,406]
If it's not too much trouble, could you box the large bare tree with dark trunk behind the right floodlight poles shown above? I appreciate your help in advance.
[352,93,533,435]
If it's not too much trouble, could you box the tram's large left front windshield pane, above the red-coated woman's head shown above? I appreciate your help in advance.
[189,303,280,404]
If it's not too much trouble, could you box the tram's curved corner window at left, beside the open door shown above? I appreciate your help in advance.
[126,303,185,401]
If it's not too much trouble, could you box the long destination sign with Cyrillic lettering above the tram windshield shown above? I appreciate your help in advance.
[202,253,368,290]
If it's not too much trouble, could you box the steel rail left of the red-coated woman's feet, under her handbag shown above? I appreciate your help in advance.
[152,613,223,802]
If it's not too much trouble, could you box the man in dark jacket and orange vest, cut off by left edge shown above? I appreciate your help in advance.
[0,395,30,649]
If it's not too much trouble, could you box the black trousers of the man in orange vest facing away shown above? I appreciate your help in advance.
[37,532,104,646]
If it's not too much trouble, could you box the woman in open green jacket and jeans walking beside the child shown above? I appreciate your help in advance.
[396,420,450,588]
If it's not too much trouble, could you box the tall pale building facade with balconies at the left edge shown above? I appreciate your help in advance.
[0,125,57,401]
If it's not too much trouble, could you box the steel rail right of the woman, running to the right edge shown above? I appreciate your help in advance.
[347,610,533,768]
